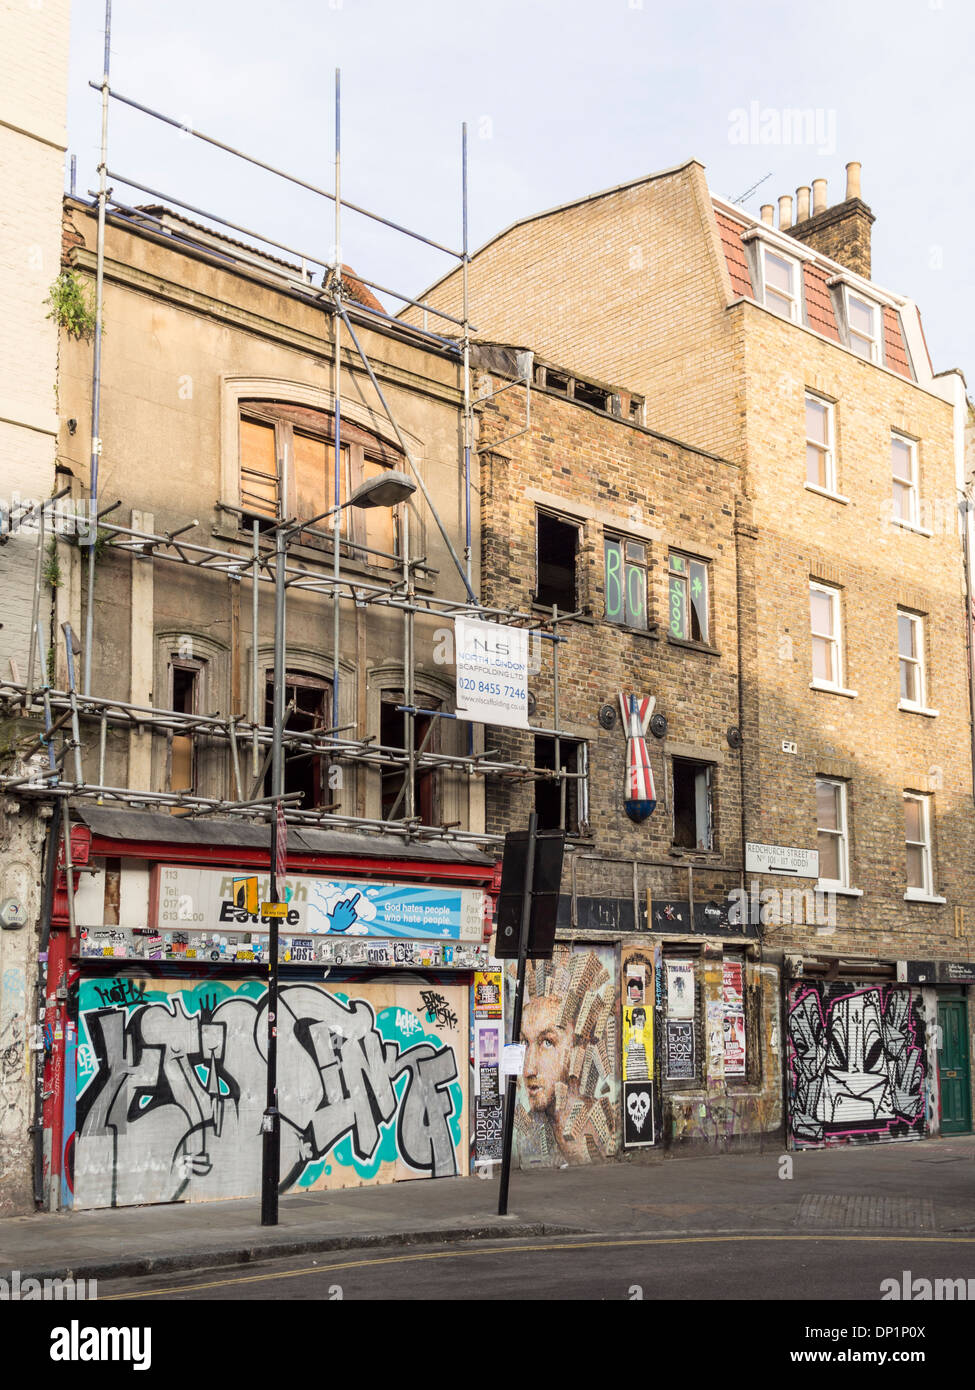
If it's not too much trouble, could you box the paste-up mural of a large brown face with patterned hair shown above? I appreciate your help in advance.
[509,945,620,1166]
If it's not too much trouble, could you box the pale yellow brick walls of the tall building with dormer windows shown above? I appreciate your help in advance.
[450,161,975,1141]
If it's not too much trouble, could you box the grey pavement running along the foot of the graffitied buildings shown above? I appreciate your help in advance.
[0,1136,975,1280]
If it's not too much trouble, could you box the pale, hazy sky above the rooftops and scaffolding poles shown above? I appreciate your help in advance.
[68,0,975,383]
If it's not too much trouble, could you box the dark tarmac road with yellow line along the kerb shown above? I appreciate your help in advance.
[99,1233,975,1321]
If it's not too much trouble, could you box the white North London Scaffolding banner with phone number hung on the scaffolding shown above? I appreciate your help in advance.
[453,617,530,728]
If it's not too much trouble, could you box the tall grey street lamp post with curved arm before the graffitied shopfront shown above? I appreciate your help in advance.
[255,468,416,1226]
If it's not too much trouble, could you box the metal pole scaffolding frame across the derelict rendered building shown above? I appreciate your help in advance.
[0,10,586,844]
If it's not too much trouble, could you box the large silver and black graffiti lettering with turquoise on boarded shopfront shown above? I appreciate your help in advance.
[74,980,467,1207]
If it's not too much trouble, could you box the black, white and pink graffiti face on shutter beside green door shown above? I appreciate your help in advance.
[789,983,925,1145]
